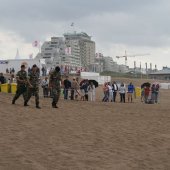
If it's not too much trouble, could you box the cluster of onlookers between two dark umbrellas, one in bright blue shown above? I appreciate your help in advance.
[102,81,135,103]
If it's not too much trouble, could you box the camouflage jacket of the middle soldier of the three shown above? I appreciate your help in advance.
[28,71,40,88]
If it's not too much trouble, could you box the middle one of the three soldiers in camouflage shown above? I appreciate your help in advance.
[24,64,40,109]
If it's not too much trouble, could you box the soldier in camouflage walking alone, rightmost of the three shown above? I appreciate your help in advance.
[49,66,61,108]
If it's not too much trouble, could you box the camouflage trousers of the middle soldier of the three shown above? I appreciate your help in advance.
[25,87,39,106]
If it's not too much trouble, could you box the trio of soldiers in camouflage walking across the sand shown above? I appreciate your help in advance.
[12,64,61,109]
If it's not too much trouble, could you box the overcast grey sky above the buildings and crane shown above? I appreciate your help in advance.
[0,0,170,69]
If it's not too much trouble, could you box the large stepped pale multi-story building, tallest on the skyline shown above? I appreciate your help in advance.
[37,32,95,70]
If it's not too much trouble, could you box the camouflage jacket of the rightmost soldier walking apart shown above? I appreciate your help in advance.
[50,71,61,88]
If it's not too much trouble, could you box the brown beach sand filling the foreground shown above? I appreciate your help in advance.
[0,79,170,170]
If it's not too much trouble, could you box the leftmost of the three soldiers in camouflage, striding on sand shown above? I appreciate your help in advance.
[12,65,27,104]
